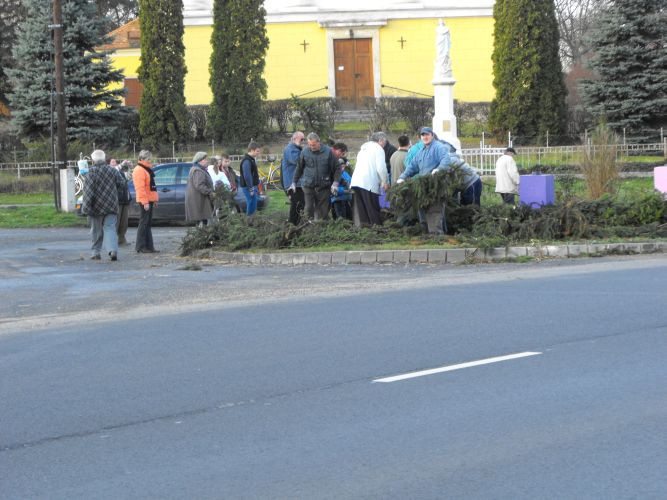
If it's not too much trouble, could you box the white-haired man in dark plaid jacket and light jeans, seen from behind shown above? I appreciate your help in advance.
[81,149,125,260]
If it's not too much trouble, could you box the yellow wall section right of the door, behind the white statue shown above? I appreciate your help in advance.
[380,18,494,102]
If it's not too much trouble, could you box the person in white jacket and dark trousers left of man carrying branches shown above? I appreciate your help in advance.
[350,133,389,226]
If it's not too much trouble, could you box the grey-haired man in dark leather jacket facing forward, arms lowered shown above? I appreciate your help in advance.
[288,132,340,220]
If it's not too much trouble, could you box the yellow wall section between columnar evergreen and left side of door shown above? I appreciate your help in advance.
[264,22,329,99]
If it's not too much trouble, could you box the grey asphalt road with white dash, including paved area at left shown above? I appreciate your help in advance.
[0,229,667,499]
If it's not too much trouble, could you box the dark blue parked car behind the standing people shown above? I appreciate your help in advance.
[76,162,269,223]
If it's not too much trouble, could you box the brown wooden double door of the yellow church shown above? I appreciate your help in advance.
[334,38,374,108]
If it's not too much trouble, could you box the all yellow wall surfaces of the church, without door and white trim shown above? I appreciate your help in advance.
[112,17,494,104]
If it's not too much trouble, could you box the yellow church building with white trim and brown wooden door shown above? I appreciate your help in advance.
[107,0,494,106]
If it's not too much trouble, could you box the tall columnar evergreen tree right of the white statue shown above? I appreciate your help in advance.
[490,0,567,142]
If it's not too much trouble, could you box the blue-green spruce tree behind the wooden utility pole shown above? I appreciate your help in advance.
[8,0,124,143]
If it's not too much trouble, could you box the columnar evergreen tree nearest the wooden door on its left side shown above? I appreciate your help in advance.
[208,0,269,144]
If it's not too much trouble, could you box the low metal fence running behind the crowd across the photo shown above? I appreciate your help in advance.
[0,142,667,179]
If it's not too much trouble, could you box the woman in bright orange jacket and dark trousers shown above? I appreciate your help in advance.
[132,149,159,253]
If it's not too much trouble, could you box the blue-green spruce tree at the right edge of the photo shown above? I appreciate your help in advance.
[581,0,667,141]
